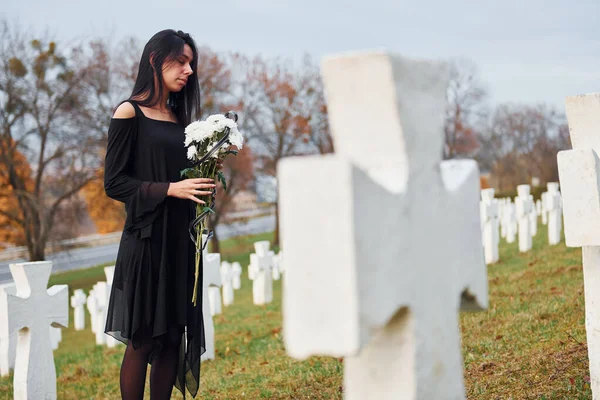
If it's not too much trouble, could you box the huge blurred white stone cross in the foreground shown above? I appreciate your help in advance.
[278,53,487,400]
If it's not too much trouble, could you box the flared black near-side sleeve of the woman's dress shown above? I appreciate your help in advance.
[104,117,169,237]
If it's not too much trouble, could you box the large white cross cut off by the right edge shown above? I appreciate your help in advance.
[548,93,600,399]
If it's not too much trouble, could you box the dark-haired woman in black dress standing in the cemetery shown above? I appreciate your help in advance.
[104,30,215,400]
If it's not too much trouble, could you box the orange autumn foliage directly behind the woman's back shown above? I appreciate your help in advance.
[82,168,126,233]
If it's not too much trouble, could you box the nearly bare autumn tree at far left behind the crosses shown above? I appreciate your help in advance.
[0,22,98,261]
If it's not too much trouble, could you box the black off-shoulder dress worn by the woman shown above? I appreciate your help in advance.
[104,101,206,397]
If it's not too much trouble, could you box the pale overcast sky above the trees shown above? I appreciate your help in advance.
[0,0,600,109]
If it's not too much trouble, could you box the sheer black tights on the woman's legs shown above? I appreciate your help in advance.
[121,329,182,400]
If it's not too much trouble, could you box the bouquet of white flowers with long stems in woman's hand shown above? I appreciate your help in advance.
[181,111,244,305]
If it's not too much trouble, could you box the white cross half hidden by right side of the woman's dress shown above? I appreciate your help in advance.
[200,239,221,361]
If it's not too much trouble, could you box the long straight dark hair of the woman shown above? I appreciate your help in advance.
[130,29,200,126]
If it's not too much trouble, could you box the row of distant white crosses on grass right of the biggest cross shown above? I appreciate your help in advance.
[479,182,562,264]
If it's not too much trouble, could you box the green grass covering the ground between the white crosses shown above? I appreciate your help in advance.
[0,225,591,400]
